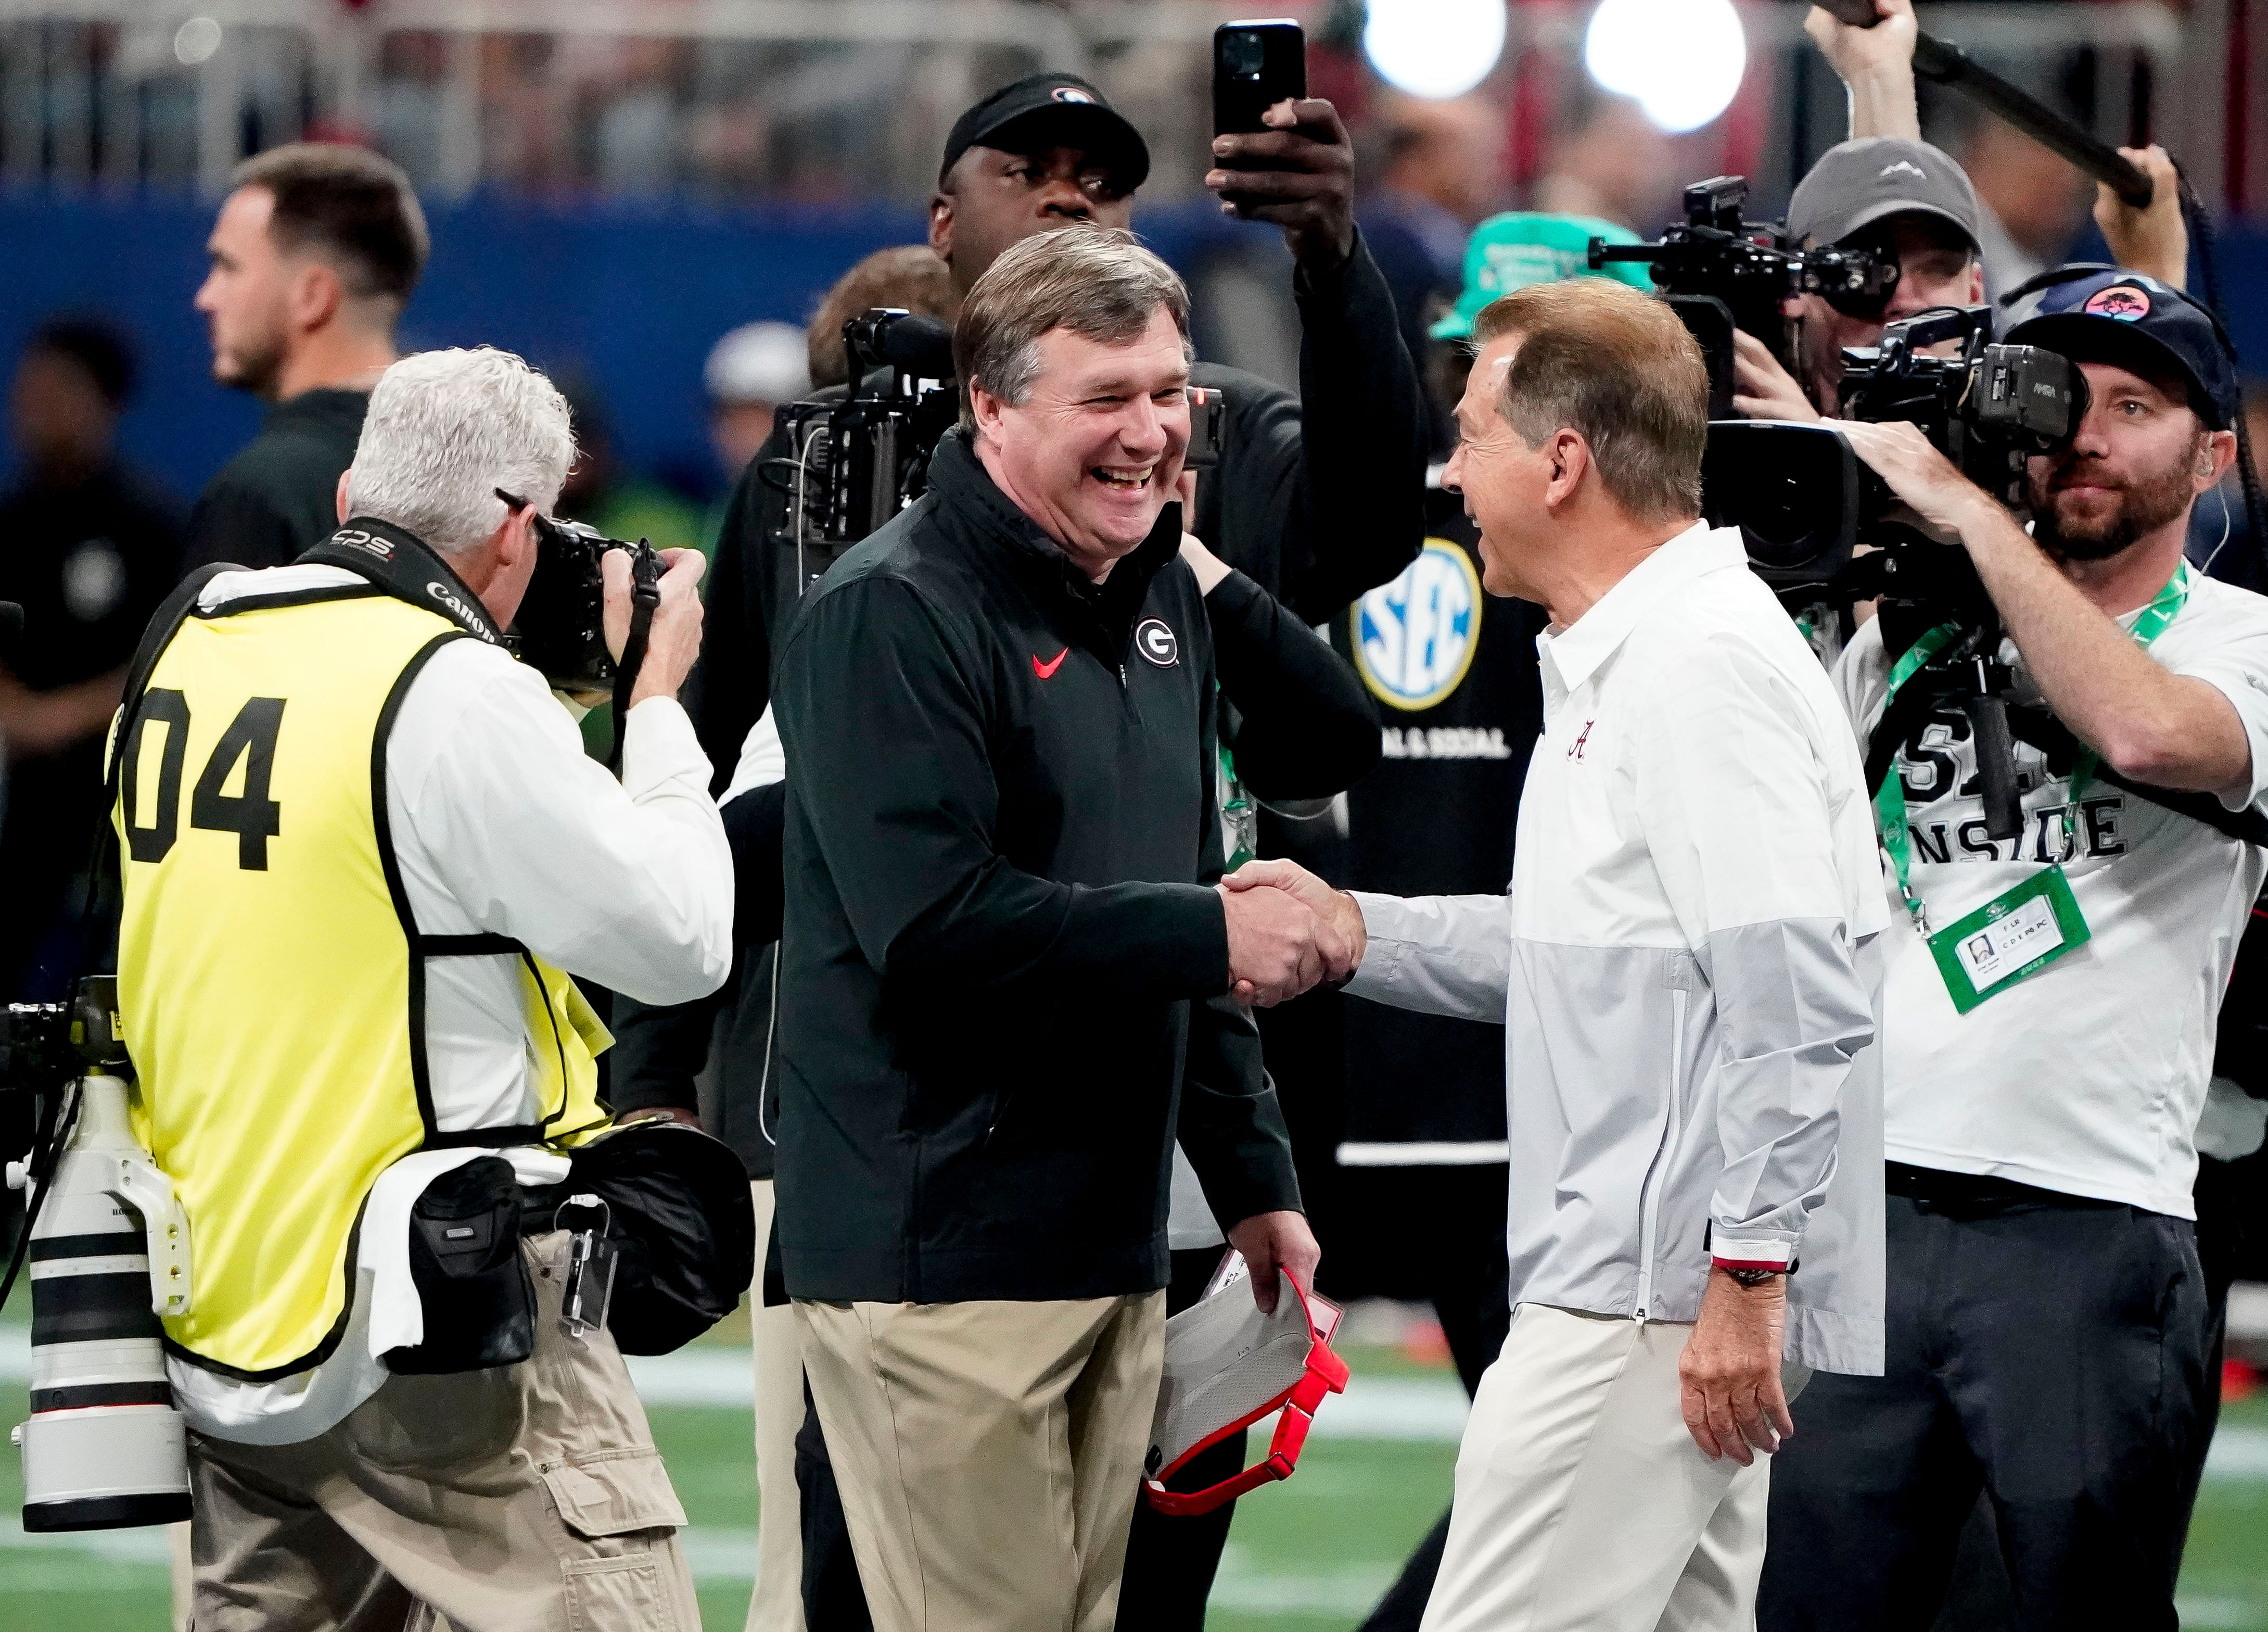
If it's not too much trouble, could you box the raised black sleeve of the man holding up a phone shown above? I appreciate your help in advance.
[1195,238,1426,624]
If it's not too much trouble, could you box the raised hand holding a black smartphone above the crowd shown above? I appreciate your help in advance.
[1204,20,1354,270]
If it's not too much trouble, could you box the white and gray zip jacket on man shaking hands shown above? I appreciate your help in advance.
[1347,524,1887,1375]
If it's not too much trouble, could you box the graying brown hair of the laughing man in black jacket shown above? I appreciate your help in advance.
[952,225,1195,429]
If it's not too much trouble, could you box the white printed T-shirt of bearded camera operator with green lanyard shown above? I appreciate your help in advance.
[1835,572,2268,1219]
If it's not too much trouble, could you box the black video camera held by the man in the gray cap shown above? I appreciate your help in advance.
[1590,175,1899,420]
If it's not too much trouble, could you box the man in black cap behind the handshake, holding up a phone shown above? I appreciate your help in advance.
[694,73,1426,788]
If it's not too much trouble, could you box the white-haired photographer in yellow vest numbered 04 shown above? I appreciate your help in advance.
[111,349,730,1632]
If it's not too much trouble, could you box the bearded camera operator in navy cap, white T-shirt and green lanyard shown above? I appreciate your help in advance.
[1760,272,2268,1632]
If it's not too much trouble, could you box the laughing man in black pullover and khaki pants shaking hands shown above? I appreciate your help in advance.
[775,232,1345,1632]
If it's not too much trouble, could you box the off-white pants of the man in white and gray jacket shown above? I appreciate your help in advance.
[1424,1303,1810,1632]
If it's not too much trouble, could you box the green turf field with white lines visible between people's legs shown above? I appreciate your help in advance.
[0,1353,2268,1632]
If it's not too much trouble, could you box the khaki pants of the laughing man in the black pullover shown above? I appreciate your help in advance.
[796,1292,1166,1632]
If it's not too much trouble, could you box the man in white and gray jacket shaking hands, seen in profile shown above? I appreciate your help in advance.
[1229,279,1884,1632]
